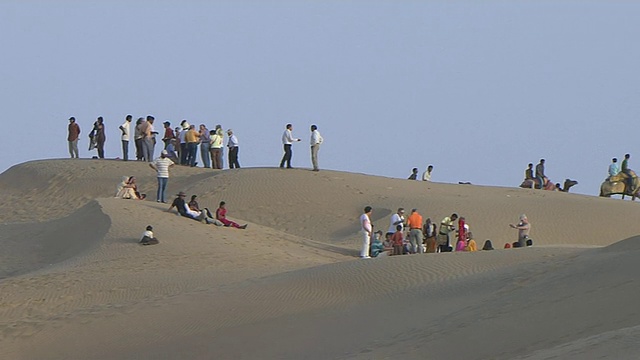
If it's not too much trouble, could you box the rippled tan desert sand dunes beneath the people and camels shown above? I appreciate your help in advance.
[0,160,640,359]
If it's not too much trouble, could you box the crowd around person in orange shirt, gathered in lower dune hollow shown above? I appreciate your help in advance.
[360,206,533,259]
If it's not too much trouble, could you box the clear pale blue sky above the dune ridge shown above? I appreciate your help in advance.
[0,0,640,194]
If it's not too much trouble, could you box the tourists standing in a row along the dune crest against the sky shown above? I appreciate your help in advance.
[67,115,324,171]
